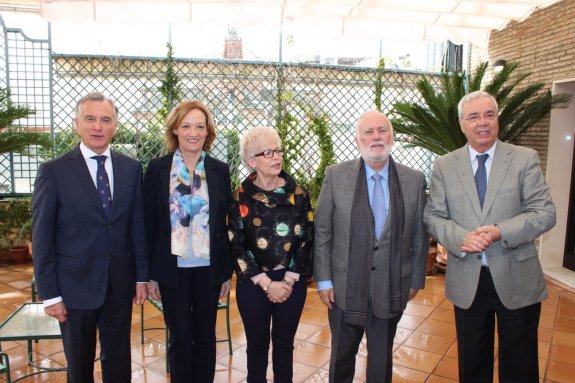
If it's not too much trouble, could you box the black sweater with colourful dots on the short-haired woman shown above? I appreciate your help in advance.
[228,171,313,281]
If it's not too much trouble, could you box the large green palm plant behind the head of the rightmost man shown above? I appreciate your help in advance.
[392,62,570,155]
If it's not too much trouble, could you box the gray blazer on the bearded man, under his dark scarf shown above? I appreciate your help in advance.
[314,159,429,317]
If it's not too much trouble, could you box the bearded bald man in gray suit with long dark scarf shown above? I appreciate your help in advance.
[314,110,429,383]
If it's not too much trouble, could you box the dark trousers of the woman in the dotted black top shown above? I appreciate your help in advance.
[236,269,307,383]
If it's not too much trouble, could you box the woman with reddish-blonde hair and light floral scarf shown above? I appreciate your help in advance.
[144,100,232,383]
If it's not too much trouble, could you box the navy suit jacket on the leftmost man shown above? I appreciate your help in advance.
[32,147,148,310]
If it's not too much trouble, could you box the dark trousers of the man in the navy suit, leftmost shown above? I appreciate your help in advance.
[60,294,132,383]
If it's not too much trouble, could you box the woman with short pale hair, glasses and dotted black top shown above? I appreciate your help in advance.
[228,127,313,383]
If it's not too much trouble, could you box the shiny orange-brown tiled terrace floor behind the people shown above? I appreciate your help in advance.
[0,263,575,383]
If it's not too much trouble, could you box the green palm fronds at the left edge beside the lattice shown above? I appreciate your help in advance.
[0,88,51,155]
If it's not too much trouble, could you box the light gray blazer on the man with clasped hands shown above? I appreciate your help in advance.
[424,141,555,309]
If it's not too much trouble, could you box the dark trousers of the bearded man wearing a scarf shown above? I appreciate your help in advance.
[328,304,402,383]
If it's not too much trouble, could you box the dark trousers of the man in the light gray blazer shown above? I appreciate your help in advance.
[455,268,541,383]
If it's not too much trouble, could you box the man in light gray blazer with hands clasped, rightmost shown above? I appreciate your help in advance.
[424,91,555,383]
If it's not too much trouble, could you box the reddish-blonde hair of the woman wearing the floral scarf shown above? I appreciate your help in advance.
[164,100,216,153]
